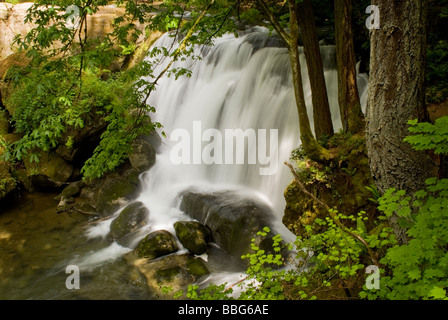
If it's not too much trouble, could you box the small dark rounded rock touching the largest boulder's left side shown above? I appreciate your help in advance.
[174,221,211,255]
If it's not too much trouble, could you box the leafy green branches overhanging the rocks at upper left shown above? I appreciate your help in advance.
[4,0,242,179]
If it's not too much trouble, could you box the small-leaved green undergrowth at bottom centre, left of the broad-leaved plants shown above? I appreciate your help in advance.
[182,212,395,300]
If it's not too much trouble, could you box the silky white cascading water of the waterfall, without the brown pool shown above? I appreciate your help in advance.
[82,28,367,264]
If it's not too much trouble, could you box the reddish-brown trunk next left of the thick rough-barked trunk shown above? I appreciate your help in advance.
[334,0,365,133]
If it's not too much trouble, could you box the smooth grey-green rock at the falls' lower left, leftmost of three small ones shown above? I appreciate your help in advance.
[109,201,149,246]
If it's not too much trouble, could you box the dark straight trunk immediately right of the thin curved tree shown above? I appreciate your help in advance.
[297,0,334,140]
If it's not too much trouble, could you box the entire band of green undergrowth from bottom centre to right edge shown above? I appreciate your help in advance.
[182,114,448,300]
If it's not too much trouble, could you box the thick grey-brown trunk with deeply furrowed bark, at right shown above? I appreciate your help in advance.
[367,0,436,243]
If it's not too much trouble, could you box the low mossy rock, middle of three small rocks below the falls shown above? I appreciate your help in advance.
[134,230,179,259]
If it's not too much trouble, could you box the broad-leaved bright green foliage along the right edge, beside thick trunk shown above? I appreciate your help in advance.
[360,117,448,300]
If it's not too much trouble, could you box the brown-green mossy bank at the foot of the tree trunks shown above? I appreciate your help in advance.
[283,134,376,236]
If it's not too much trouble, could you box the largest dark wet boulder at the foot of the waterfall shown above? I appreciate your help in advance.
[180,191,284,258]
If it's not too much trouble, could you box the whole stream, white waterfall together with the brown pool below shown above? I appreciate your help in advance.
[0,27,368,299]
